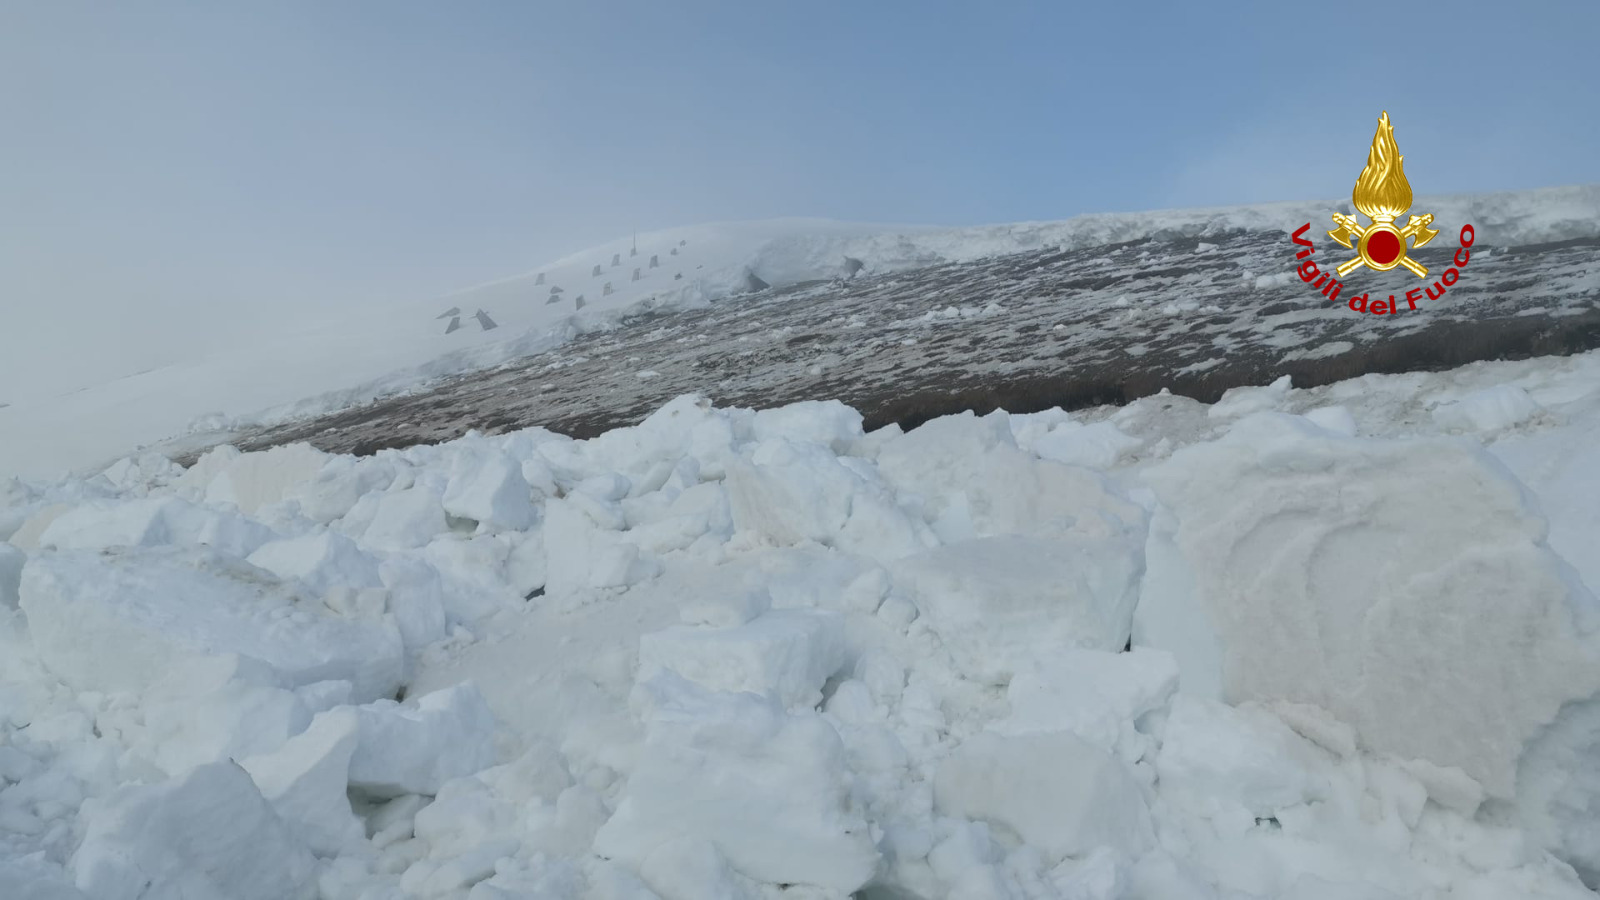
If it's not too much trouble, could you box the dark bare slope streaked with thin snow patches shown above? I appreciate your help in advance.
[228,184,1600,453]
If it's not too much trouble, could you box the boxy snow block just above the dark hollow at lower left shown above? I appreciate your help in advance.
[350,682,494,798]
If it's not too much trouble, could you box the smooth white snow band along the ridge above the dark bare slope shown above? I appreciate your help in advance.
[0,179,1600,476]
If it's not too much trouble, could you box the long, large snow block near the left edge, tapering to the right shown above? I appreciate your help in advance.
[21,548,402,700]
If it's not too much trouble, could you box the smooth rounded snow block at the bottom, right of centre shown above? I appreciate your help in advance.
[933,732,1155,862]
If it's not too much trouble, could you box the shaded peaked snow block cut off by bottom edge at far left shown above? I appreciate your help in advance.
[72,762,317,900]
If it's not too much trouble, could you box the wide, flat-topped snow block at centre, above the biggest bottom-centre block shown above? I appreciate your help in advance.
[638,610,851,706]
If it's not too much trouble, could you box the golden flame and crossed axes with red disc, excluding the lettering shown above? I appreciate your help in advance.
[1328,110,1438,279]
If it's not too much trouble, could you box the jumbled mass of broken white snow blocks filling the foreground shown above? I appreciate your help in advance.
[0,347,1600,900]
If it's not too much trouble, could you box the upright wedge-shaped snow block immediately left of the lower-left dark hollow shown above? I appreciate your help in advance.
[240,708,366,857]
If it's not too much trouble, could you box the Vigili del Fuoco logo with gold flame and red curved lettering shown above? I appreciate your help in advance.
[1293,110,1477,315]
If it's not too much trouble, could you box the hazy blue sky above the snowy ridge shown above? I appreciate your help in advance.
[0,0,1600,366]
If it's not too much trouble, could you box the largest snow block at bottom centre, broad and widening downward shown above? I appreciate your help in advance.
[594,673,878,894]
